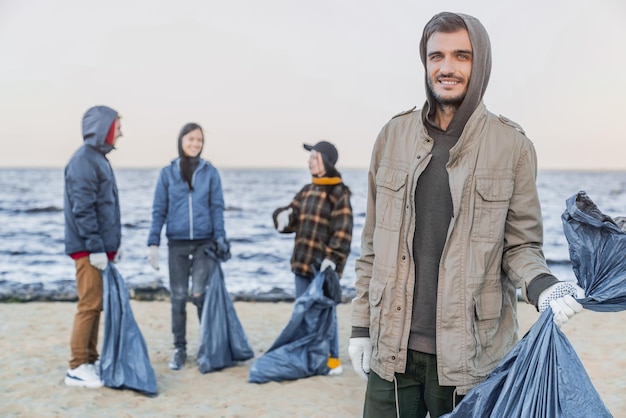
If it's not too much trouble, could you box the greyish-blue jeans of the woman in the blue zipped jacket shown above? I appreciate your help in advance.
[168,243,217,349]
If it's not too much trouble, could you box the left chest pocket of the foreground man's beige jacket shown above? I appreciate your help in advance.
[376,167,407,231]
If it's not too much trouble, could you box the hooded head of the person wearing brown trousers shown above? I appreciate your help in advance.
[83,106,118,154]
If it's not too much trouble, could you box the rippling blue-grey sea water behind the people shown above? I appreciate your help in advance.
[0,168,626,299]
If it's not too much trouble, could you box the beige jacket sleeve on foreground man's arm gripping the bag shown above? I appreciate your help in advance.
[502,138,550,301]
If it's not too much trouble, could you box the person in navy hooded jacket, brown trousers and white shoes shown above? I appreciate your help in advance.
[64,106,122,388]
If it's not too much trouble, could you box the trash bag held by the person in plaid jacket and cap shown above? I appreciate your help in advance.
[248,272,336,383]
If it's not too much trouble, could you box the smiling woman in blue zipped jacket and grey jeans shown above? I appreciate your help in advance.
[148,123,230,370]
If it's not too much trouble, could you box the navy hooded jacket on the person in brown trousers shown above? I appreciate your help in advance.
[64,106,122,254]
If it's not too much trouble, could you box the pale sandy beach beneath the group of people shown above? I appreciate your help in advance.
[0,300,626,417]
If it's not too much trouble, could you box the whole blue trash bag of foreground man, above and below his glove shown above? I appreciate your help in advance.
[445,192,626,418]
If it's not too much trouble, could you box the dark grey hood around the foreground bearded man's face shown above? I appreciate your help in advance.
[420,12,491,135]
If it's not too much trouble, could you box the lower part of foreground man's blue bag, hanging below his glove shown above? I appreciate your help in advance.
[444,309,612,418]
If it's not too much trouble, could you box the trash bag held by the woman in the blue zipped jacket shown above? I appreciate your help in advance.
[196,252,254,373]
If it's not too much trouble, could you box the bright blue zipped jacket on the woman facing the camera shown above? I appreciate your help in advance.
[148,158,226,245]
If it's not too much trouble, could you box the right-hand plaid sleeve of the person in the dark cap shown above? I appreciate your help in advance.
[326,187,353,266]
